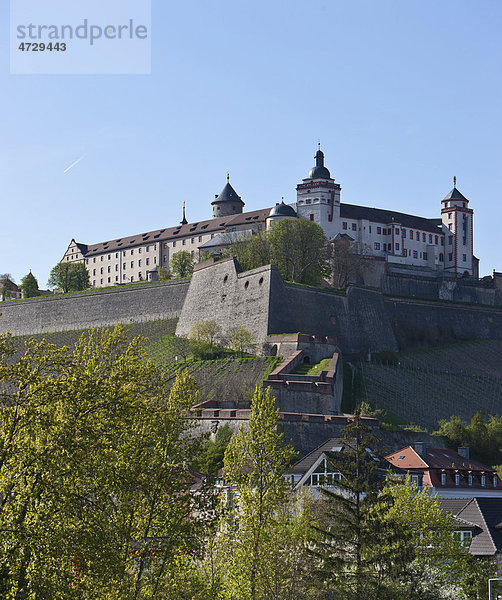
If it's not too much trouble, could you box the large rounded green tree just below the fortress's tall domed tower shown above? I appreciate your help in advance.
[268,219,330,284]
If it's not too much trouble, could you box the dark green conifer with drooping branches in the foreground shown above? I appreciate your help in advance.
[312,411,411,600]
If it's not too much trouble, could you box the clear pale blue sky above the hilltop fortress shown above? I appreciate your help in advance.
[0,0,502,287]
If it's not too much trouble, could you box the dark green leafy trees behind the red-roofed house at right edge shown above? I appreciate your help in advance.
[436,412,502,470]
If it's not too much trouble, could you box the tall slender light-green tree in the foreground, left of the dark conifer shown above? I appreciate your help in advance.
[223,386,294,600]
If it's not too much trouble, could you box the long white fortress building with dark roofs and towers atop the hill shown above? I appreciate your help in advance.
[62,147,479,287]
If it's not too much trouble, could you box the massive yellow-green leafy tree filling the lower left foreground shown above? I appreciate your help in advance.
[0,327,204,600]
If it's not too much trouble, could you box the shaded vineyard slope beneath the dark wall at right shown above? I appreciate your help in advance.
[361,340,502,429]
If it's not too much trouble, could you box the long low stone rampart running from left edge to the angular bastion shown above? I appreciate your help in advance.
[0,281,189,335]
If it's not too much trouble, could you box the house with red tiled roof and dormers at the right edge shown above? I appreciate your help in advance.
[385,442,502,500]
